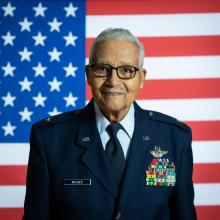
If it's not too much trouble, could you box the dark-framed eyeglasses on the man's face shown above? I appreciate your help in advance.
[89,64,140,79]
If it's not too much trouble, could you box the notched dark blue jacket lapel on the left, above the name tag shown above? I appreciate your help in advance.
[77,100,117,198]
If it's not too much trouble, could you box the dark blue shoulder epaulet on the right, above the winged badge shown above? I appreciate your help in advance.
[148,111,190,131]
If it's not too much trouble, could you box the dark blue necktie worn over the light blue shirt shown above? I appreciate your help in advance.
[105,123,125,186]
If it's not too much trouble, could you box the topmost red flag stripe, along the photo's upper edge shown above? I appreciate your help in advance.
[87,0,220,15]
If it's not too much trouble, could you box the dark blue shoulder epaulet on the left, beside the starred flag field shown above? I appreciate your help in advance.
[32,110,80,126]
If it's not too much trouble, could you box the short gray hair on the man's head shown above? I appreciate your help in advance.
[89,28,144,67]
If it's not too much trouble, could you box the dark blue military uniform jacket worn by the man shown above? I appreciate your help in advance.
[23,100,196,220]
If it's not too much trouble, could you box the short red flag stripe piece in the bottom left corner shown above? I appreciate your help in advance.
[0,208,23,220]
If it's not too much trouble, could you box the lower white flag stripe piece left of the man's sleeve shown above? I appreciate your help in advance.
[0,186,26,208]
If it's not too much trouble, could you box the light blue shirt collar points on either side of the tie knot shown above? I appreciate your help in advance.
[94,101,135,138]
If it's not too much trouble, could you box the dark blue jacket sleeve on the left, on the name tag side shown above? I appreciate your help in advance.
[23,126,50,220]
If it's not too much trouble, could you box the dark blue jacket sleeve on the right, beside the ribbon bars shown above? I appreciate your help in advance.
[172,129,197,220]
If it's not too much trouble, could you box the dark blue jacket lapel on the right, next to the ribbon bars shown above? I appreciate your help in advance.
[119,103,154,206]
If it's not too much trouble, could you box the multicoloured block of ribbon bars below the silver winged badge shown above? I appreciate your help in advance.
[146,158,176,186]
